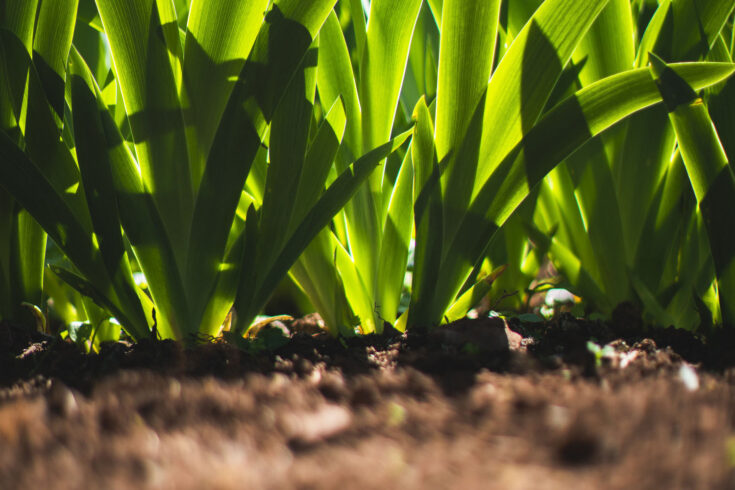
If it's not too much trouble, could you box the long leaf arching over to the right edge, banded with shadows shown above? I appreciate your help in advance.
[420,63,734,328]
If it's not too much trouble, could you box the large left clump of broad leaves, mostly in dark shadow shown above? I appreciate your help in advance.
[0,0,410,341]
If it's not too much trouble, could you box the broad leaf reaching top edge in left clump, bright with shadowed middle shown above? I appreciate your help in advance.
[96,0,194,269]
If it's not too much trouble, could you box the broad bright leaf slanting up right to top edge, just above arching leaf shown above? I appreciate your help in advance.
[409,0,607,326]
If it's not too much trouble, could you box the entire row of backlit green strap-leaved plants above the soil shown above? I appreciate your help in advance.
[0,0,735,346]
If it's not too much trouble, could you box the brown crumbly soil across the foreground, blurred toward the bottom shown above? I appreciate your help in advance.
[0,309,735,489]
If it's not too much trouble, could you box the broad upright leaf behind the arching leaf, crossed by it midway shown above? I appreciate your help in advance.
[542,0,635,305]
